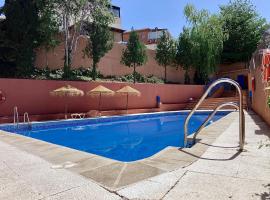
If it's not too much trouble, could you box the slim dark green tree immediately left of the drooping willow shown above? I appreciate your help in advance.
[174,28,193,84]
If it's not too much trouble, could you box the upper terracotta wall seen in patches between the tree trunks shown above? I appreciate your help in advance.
[35,37,193,83]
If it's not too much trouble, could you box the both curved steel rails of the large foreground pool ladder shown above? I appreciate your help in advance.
[184,78,245,151]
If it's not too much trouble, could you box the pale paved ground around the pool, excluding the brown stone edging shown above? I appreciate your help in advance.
[0,113,270,200]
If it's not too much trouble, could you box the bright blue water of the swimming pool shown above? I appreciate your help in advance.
[0,112,229,162]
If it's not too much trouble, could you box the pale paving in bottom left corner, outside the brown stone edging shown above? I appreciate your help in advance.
[0,141,119,200]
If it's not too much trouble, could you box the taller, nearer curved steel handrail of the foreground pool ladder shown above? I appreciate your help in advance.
[184,78,245,150]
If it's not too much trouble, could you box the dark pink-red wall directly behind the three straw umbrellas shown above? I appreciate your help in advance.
[0,79,203,117]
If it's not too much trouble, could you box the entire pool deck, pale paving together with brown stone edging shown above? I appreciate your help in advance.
[0,113,270,200]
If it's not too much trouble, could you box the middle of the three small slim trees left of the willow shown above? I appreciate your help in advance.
[155,31,175,83]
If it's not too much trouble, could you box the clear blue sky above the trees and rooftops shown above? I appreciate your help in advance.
[0,0,270,37]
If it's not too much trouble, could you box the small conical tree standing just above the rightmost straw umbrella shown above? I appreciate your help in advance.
[121,31,147,83]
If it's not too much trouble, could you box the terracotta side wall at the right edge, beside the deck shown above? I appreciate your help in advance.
[249,67,270,125]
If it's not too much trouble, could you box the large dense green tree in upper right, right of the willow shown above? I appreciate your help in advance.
[220,0,266,62]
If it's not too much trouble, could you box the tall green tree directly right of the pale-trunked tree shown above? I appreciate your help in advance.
[84,1,113,80]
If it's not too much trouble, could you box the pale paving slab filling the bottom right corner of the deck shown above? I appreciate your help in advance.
[164,172,269,200]
